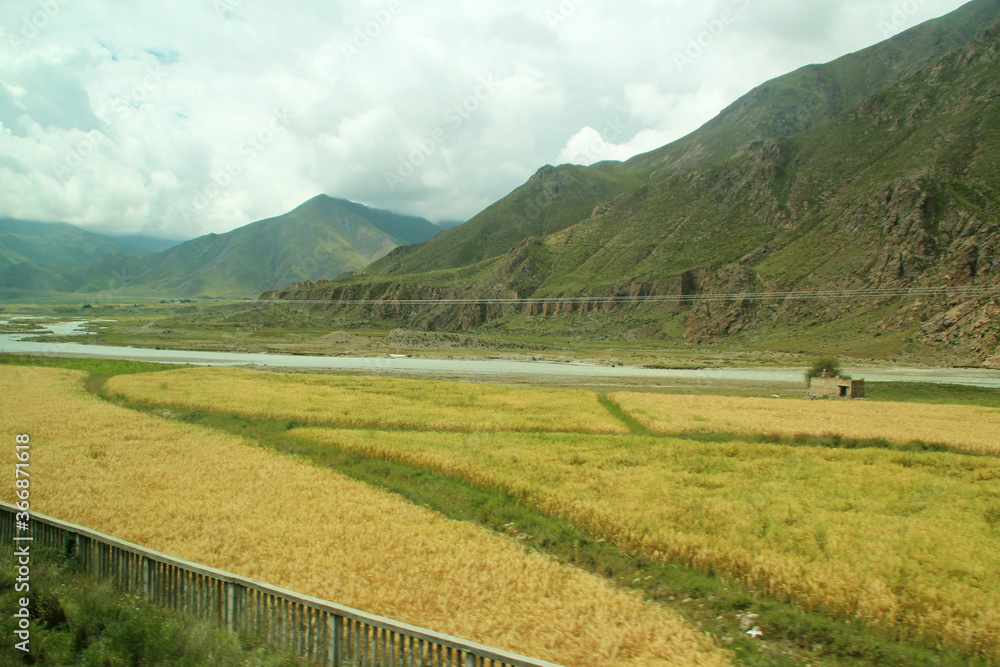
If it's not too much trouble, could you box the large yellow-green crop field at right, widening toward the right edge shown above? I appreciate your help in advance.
[291,428,1000,661]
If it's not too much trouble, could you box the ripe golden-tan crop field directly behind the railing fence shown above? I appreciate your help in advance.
[0,366,726,666]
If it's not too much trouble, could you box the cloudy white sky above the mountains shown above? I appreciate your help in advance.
[0,0,964,239]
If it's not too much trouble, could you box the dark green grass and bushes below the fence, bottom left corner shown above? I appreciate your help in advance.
[0,545,305,667]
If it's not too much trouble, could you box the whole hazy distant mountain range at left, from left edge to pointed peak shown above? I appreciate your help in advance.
[0,195,440,299]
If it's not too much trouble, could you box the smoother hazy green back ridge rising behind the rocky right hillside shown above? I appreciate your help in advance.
[363,0,1000,276]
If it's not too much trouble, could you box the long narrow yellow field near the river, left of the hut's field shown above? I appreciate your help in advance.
[107,368,628,433]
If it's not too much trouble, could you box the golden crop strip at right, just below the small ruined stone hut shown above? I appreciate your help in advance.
[611,392,1000,455]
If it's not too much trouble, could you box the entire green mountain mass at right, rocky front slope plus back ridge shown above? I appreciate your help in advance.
[261,0,1000,363]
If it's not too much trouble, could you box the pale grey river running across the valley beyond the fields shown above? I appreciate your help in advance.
[0,318,1000,388]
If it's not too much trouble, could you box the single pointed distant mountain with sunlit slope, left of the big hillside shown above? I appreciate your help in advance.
[74,195,438,297]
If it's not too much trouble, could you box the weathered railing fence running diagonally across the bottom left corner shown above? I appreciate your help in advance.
[0,502,559,667]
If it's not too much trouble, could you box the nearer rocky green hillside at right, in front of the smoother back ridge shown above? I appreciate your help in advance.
[262,3,1000,363]
